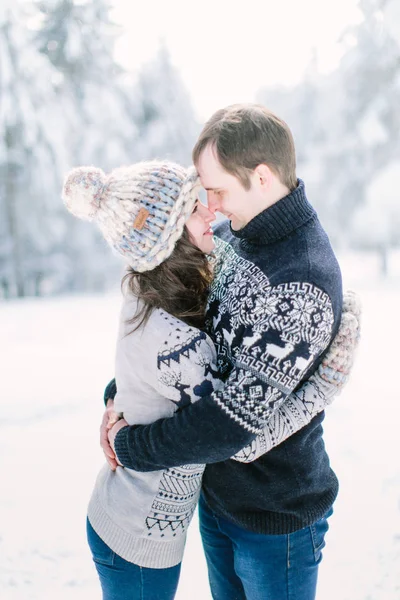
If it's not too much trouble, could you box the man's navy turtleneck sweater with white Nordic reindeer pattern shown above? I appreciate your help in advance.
[111,180,342,534]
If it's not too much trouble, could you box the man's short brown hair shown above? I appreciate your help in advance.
[192,104,297,191]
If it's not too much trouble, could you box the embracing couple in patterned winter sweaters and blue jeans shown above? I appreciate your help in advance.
[63,104,360,600]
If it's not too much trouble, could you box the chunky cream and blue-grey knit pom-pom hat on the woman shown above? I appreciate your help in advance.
[62,161,200,272]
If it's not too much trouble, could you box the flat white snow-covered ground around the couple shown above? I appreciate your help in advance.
[0,269,400,600]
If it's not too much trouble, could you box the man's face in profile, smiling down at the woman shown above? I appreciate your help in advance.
[197,145,255,230]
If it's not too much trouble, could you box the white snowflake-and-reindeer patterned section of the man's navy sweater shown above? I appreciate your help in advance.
[209,240,334,435]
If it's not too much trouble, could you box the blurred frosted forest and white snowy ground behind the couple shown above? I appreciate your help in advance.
[0,0,400,600]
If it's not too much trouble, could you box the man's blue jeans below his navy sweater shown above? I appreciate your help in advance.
[199,497,333,600]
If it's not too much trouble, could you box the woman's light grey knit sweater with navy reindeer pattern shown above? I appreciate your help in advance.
[88,295,337,568]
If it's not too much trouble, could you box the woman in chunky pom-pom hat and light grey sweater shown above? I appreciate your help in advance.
[63,161,358,600]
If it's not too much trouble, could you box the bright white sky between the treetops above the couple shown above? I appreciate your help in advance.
[112,0,360,120]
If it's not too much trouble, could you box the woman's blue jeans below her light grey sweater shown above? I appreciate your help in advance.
[86,519,181,600]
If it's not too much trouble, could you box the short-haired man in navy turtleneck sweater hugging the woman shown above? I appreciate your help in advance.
[103,105,342,600]
